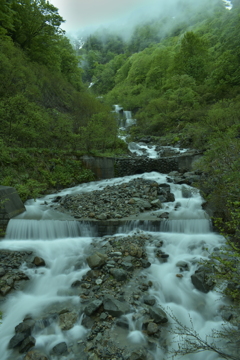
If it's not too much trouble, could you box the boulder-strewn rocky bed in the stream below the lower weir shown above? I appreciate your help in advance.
[0,230,229,360]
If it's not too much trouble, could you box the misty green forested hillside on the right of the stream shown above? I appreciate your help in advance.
[79,0,240,245]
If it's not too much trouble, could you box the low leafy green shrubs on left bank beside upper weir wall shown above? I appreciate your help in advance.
[0,147,94,201]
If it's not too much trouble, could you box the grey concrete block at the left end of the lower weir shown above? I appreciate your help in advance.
[0,185,26,236]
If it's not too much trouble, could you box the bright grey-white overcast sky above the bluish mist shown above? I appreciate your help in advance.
[50,0,169,32]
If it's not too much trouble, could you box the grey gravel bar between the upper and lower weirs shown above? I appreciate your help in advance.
[54,171,201,220]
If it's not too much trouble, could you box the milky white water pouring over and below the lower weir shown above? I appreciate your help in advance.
[0,172,227,360]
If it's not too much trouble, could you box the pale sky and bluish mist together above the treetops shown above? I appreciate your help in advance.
[50,0,231,38]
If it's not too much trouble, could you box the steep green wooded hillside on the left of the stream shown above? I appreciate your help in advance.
[0,0,124,199]
